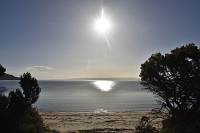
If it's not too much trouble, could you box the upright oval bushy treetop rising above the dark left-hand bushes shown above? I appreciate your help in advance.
[19,72,41,104]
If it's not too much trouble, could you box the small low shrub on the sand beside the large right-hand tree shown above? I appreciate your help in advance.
[135,116,158,133]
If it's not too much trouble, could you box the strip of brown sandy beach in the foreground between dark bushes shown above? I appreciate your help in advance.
[41,112,161,133]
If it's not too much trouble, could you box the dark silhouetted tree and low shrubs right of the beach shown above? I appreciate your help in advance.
[136,44,200,133]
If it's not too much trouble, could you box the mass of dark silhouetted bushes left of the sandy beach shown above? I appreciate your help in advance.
[0,65,58,133]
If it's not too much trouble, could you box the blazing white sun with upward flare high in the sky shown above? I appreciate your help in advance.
[94,9,111,35]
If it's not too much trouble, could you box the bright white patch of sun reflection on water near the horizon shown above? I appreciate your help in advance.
[93,80,115,92]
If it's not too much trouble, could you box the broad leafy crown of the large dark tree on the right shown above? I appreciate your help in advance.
[140,44,200,117]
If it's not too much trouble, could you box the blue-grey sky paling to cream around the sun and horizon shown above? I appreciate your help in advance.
[0,0,200,79]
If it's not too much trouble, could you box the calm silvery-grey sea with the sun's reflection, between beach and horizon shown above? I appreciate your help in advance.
[0,80,158,112]
